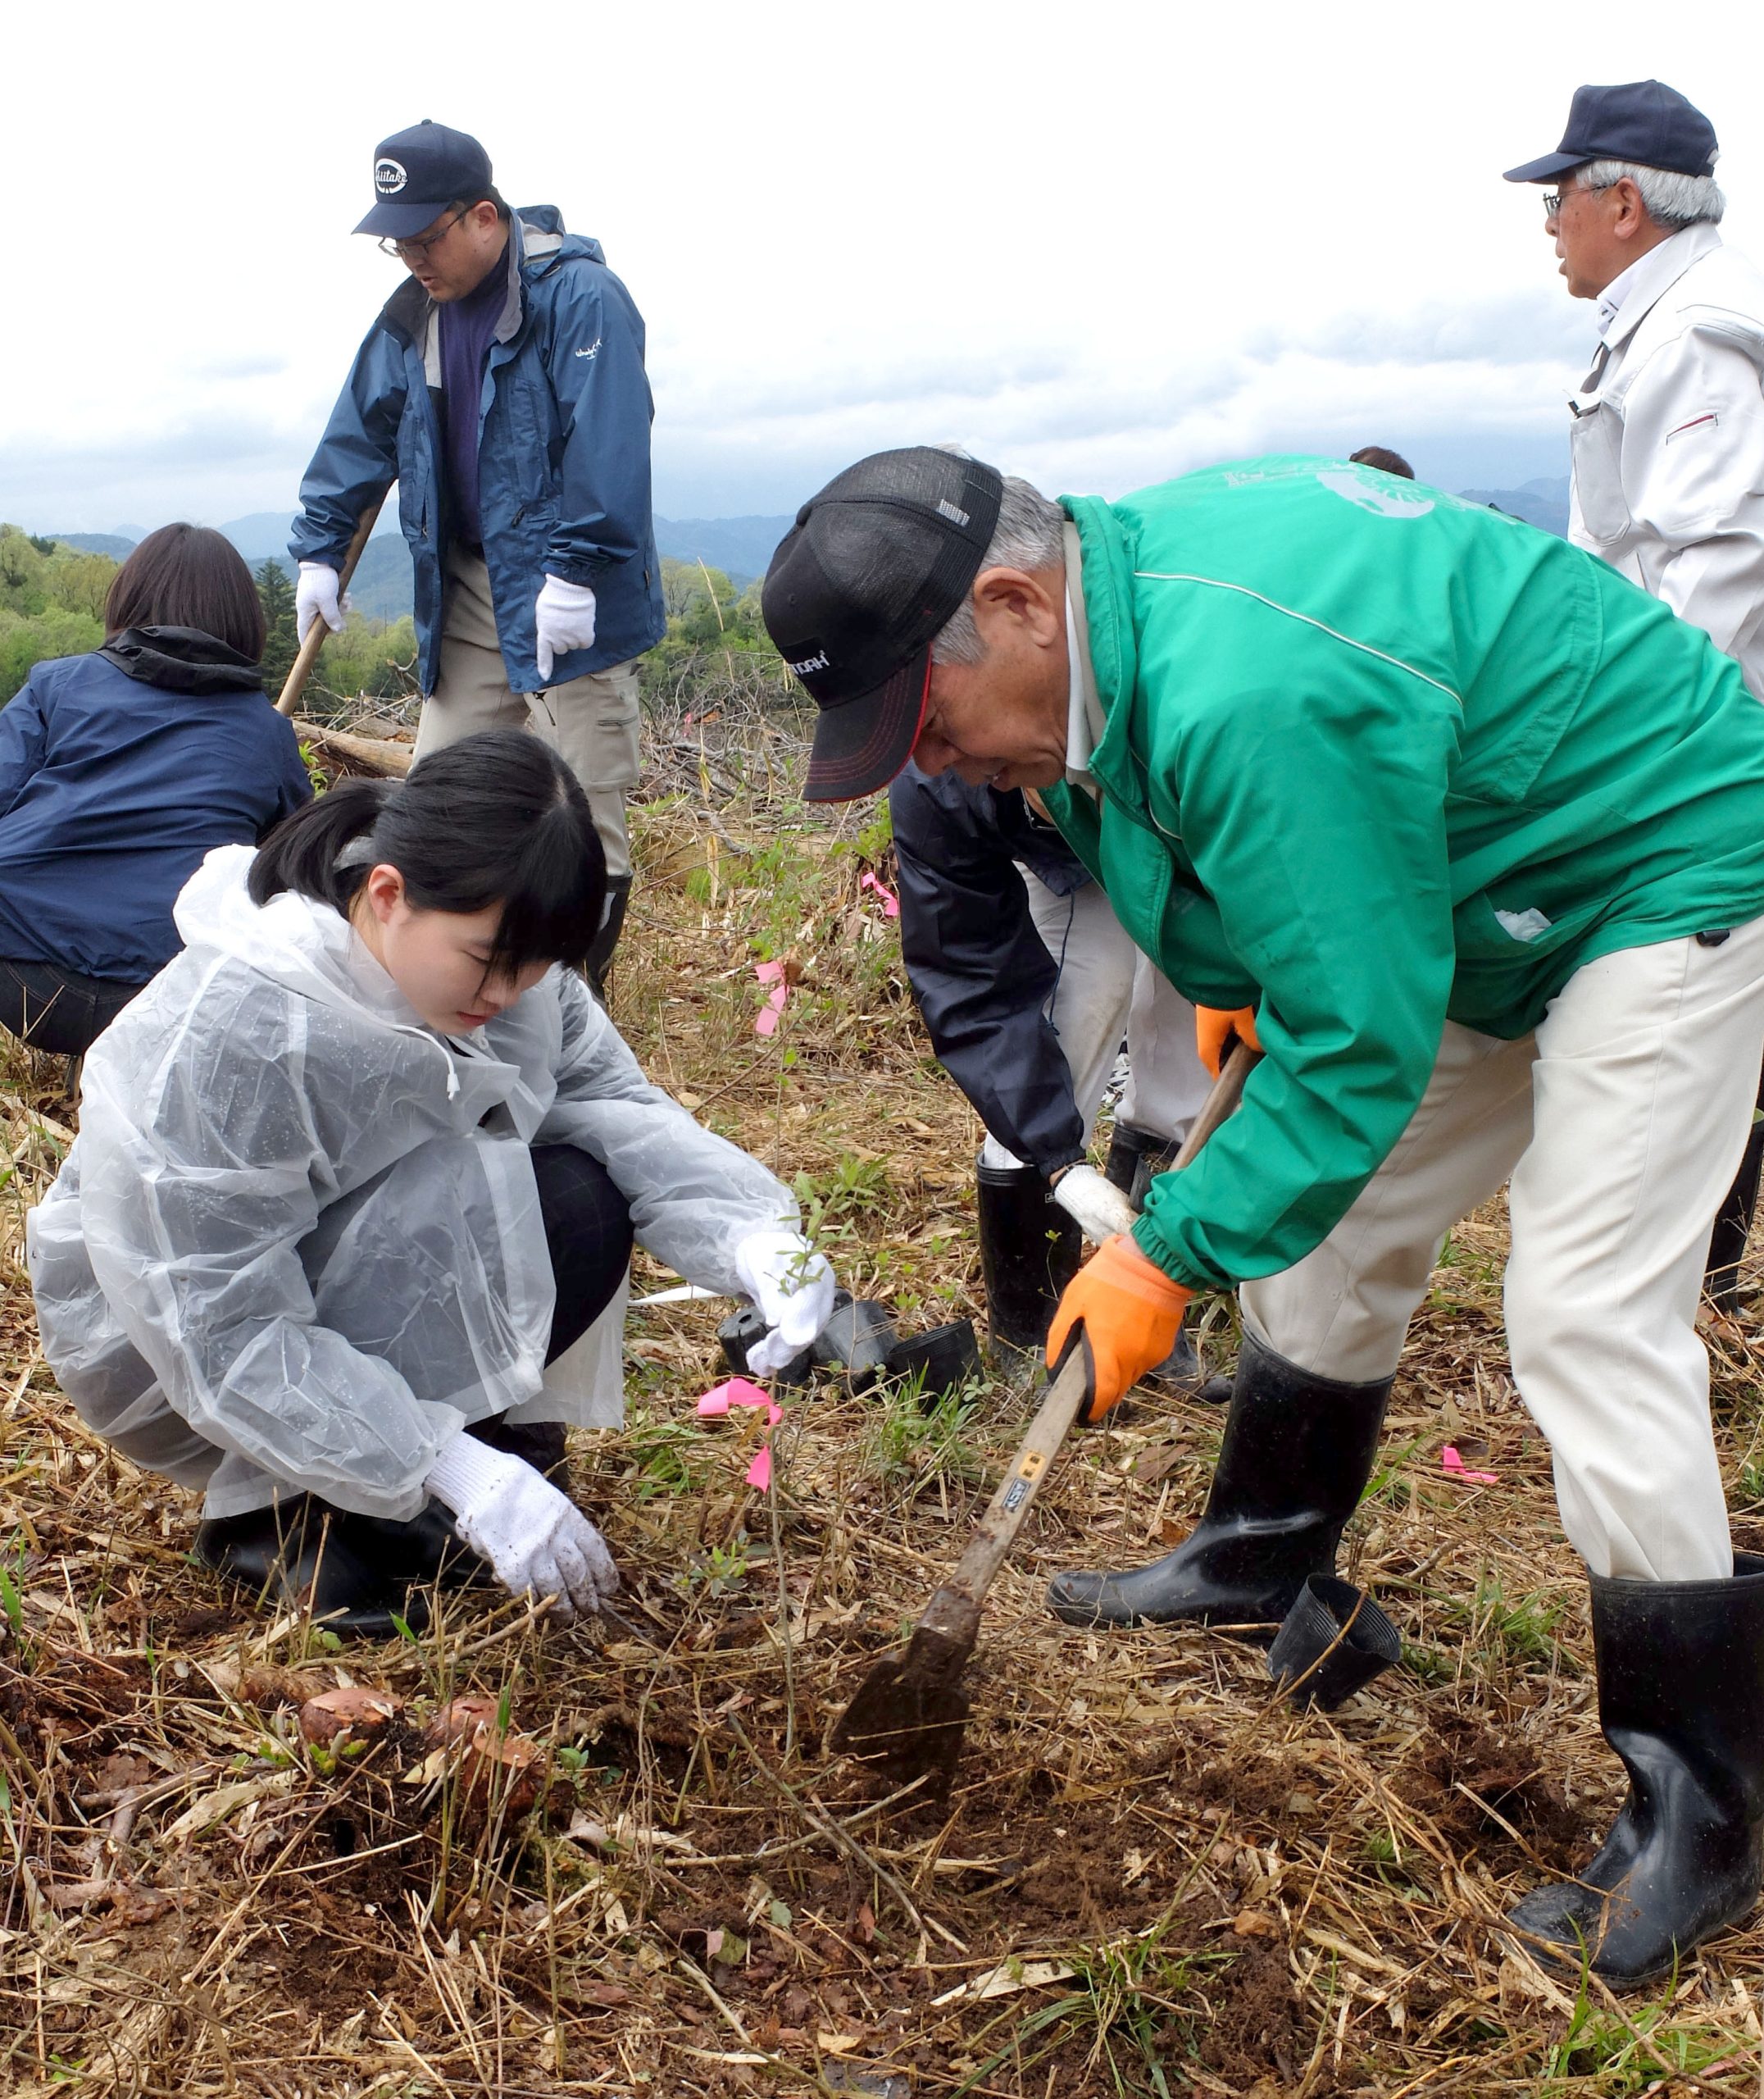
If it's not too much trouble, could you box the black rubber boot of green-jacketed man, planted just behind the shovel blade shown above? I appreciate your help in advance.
[1047,1335,1393,1639]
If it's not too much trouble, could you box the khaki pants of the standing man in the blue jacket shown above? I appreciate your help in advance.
[416,548,638,880]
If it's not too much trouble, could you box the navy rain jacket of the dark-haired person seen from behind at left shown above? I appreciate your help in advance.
[0,627,312,985]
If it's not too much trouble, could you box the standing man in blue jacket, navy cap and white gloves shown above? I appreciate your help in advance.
[292,121,665,981]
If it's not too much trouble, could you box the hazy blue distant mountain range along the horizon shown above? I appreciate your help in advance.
[48,475,1569,619]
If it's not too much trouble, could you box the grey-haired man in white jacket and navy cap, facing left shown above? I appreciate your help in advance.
[1506,80,1764,1312]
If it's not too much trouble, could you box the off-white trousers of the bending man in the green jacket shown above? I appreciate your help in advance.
[1239,919,1764,1581]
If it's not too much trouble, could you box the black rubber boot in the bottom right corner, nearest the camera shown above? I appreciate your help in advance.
[1508,1553,1764,1987]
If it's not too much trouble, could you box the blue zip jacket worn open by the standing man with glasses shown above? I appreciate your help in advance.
[289,203,667,693]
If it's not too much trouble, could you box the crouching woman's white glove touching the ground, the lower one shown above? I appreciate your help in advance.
[424,1429,619,1623]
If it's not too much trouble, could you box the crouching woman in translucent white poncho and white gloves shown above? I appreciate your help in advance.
[27,731,833,1637]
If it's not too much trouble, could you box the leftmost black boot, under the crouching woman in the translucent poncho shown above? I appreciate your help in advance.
[195,1495,417,1639]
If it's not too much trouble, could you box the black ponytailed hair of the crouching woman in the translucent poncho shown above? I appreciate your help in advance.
[250,728,607,976]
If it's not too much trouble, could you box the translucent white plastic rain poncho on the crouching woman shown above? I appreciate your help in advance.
[27,846,797,1518]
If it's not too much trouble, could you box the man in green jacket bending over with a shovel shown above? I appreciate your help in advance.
[763,449,1764,1983]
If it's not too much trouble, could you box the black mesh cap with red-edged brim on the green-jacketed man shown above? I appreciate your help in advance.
[762,445,1005,802]
